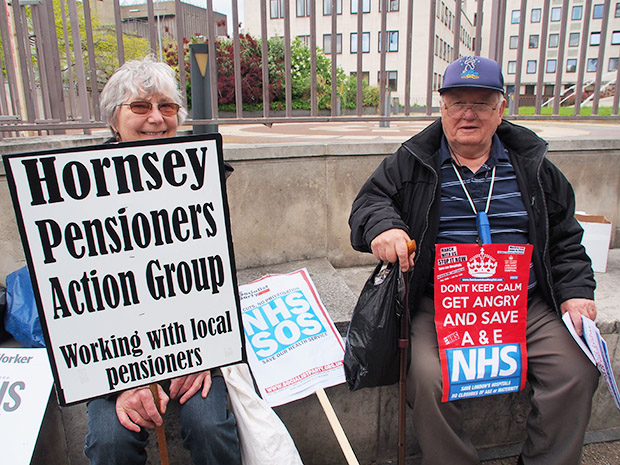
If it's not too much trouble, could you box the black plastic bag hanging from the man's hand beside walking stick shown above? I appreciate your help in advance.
[344,263,404,391]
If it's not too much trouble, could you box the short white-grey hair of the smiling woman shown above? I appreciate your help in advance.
[100,56,187,133]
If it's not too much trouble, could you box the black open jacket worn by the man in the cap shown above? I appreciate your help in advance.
[349,120,596,313]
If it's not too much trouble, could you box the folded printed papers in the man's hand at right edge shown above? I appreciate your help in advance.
[562,312,620,410]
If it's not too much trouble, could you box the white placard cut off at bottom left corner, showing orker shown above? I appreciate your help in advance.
[0,348,53,465]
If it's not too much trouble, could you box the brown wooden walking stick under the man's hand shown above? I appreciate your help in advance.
[398,241,416,465]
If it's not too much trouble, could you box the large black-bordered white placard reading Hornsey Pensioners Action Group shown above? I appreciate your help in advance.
[4,134,244,405]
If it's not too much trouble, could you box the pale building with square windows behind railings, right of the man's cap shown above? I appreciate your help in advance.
[501,0,620,105]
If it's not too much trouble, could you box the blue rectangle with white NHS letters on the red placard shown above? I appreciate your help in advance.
[446,344,521,383]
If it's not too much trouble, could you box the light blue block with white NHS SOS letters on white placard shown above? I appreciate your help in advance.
[243,291,326,360]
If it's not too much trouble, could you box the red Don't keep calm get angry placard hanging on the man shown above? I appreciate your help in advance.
[435,244,533,402]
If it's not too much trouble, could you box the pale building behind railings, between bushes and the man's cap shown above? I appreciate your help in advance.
[245,0,476,106]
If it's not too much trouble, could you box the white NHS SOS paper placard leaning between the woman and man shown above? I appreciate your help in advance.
[239,268,344,407]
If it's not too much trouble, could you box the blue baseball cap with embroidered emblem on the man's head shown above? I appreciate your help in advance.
[439,56,504,94]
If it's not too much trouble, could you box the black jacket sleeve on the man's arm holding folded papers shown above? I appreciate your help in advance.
[542,160,596,303]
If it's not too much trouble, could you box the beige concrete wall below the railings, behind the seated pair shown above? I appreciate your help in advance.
[0,138,620,282]
